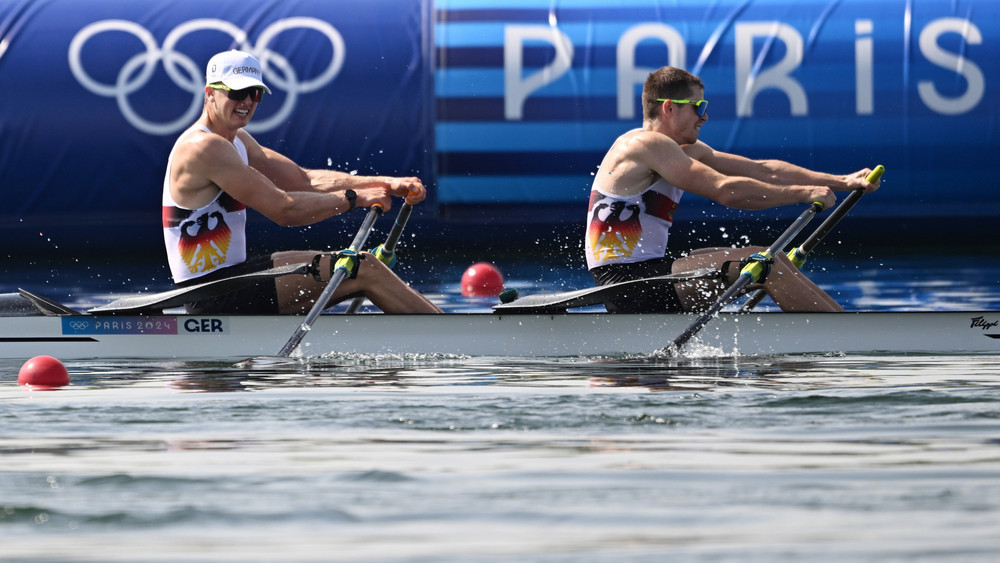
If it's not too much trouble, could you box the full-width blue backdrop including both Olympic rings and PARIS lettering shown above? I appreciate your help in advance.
[0,0,1000,252]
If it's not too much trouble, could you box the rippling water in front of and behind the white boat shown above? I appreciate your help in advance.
[0,253,1000,562]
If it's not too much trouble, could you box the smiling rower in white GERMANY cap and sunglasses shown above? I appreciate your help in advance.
[162,51,440,314]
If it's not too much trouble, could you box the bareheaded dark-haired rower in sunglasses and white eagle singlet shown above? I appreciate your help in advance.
[585,67,880,312]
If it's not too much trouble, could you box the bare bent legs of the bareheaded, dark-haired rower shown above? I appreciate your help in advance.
[673,247,844,312]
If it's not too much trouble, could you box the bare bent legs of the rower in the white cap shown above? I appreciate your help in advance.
[271,250,441,314]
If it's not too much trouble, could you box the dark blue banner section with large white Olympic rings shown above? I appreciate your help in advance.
[0,0,434,253]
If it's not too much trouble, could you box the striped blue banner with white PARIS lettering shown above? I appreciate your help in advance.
[435,0,1000,225]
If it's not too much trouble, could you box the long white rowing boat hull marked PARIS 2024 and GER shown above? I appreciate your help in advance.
[0,311,1000,360]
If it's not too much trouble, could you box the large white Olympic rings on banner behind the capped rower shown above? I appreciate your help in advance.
[69,17,345,135]
